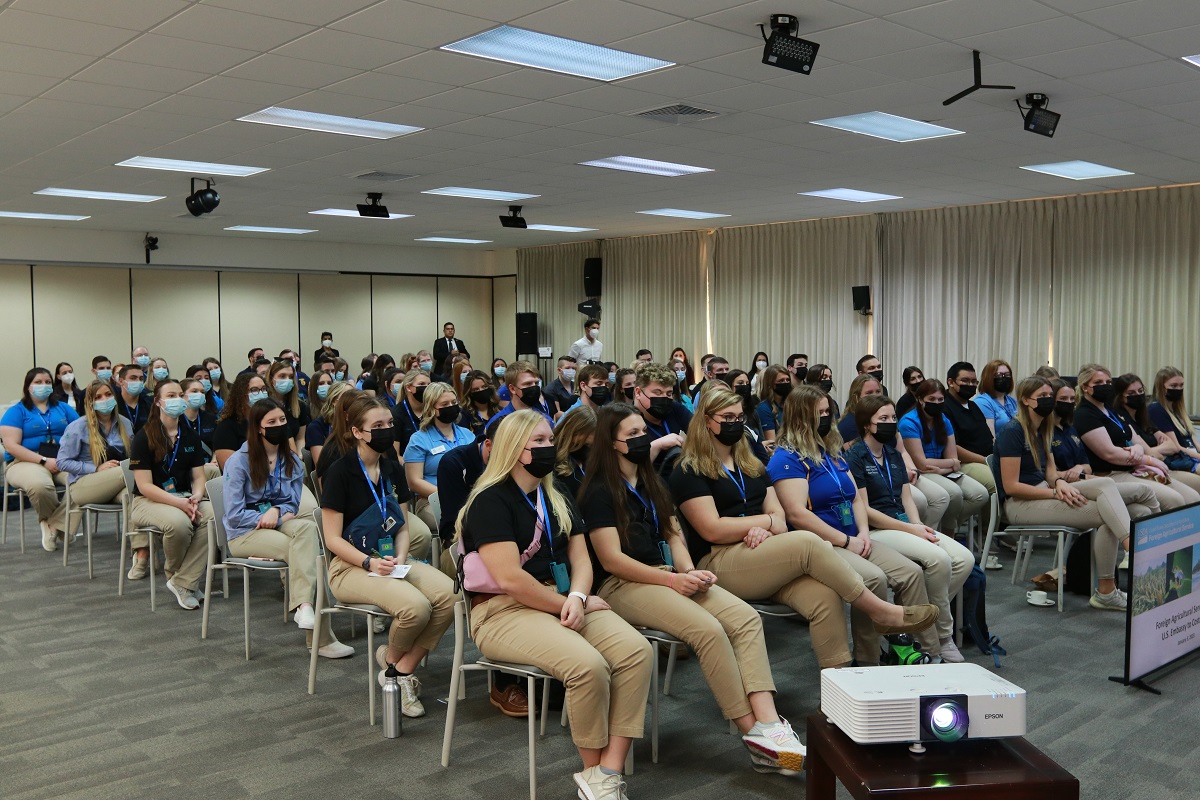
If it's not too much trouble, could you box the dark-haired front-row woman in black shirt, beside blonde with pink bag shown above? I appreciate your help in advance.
[580,407,804,775]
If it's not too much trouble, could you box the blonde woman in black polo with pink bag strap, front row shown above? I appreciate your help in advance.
[457,409,650,800]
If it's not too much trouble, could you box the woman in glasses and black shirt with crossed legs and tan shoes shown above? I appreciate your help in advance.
[670,386,937,668]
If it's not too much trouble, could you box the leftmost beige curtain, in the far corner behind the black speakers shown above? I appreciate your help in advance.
[513,241,602,359]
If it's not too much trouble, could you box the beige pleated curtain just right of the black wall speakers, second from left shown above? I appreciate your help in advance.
[600,230,710,367]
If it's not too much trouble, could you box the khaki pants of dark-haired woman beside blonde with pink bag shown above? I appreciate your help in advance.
[599,567,775,720]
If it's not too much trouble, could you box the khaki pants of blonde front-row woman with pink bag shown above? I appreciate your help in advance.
[470,595,652,750]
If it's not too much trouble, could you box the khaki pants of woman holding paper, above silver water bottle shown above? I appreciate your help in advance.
[329,558,455,658]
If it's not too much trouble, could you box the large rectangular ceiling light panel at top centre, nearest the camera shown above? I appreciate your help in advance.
[440,25,674,80]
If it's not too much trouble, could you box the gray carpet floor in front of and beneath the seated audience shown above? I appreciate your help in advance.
[0,513,1200,800]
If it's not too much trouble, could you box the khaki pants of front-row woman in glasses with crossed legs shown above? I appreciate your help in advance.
[696,530,864,668]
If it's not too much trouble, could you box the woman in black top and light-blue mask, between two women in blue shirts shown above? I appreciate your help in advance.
[130,378,212,610]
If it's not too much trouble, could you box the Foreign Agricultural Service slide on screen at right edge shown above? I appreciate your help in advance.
[1127,505,1200,680]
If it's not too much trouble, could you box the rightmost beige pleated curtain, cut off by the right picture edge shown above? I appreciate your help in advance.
[1051,186,1200,388]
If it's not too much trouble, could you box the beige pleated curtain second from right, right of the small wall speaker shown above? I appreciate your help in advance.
[875,201,1054,383]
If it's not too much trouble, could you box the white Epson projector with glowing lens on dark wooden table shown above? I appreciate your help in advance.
[821,663,1025,752]
